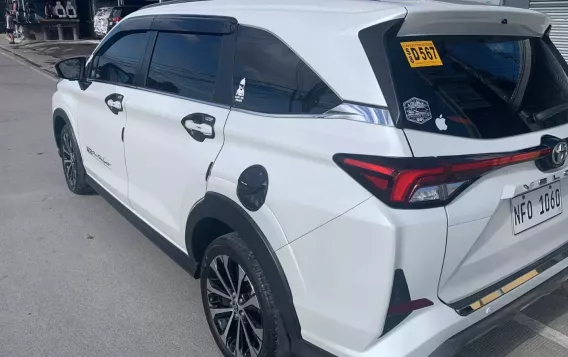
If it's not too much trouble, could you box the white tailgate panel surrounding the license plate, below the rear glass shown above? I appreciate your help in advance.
[405,125,568,303]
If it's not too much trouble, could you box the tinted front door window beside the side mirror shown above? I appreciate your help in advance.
[90,32,148,85]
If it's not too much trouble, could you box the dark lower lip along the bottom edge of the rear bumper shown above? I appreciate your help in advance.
[430,268,568,357]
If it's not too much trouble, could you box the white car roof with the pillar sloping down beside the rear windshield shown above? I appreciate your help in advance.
[128,0,544,107]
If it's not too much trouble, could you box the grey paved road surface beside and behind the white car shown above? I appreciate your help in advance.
[0,50,568,357]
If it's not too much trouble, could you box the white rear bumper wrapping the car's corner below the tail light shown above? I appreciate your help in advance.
[276,199,568,357]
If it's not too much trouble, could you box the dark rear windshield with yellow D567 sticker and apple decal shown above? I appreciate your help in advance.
[380,36,568,139]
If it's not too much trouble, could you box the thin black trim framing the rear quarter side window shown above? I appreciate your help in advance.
[231,23,346,119]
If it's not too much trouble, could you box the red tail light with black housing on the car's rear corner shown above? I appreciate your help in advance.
[333,147,551,208]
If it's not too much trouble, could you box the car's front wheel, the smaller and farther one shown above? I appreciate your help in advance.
[60,124,93,195]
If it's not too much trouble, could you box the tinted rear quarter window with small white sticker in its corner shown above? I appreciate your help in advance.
[234,26,340,114]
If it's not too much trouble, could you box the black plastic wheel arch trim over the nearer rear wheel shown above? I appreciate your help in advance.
[186,192,303,350]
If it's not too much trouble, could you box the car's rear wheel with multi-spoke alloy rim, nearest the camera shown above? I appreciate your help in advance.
[201,233,286,357]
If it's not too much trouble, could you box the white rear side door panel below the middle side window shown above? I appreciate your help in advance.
[119,88,229,246]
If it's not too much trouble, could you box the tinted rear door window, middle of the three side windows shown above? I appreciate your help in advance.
[146,33,222,101]
